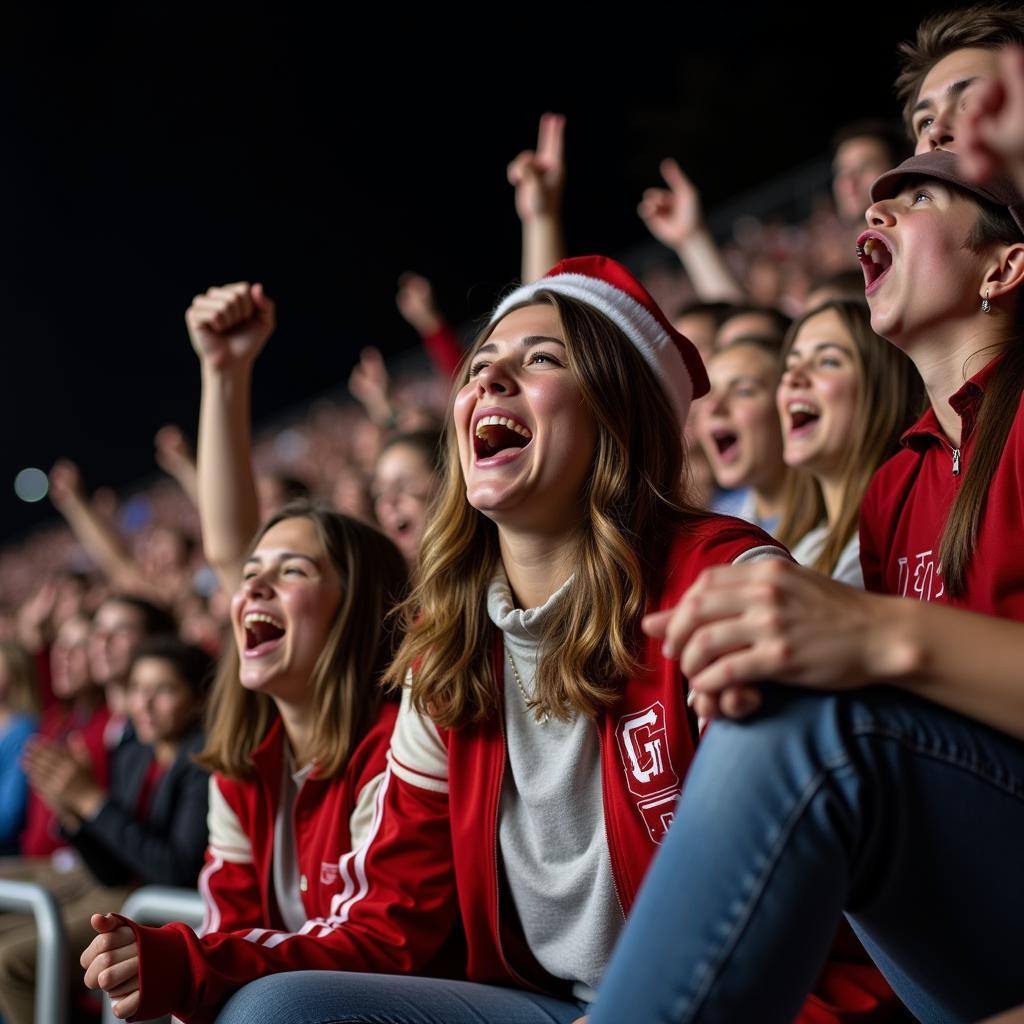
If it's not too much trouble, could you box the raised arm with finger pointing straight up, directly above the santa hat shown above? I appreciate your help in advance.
[508,114,565,284]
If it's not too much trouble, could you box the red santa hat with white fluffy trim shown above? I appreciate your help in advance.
[490,256,710,432]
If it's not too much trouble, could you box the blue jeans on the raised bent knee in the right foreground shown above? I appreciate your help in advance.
[591,679,1024,1024]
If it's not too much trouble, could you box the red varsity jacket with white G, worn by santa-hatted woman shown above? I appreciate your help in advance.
[117,517,892,1024]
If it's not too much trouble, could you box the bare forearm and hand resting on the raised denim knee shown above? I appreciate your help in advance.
[644,560,1024,739]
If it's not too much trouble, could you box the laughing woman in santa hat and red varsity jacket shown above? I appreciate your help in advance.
[82,257,878,1024]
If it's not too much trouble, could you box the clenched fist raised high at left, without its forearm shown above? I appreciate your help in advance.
[185,281,276,370]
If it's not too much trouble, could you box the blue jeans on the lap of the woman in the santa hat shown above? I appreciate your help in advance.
[217,971,587,1024]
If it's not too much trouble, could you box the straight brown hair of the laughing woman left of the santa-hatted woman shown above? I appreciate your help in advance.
[196,501,408,778]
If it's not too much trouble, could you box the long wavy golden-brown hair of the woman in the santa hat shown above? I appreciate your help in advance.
[387,291,702,727]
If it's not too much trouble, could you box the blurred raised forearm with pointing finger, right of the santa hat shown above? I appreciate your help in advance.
[637,160,746,302]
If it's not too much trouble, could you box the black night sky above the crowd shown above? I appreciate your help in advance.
[0,3,950,538]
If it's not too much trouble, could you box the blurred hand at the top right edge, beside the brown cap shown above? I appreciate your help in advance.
[956,46,1024,188]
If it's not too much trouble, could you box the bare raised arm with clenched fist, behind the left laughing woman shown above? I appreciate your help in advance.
[185,281,275,592]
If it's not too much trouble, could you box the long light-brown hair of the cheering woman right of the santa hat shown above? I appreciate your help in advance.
[777,299,925,575]
